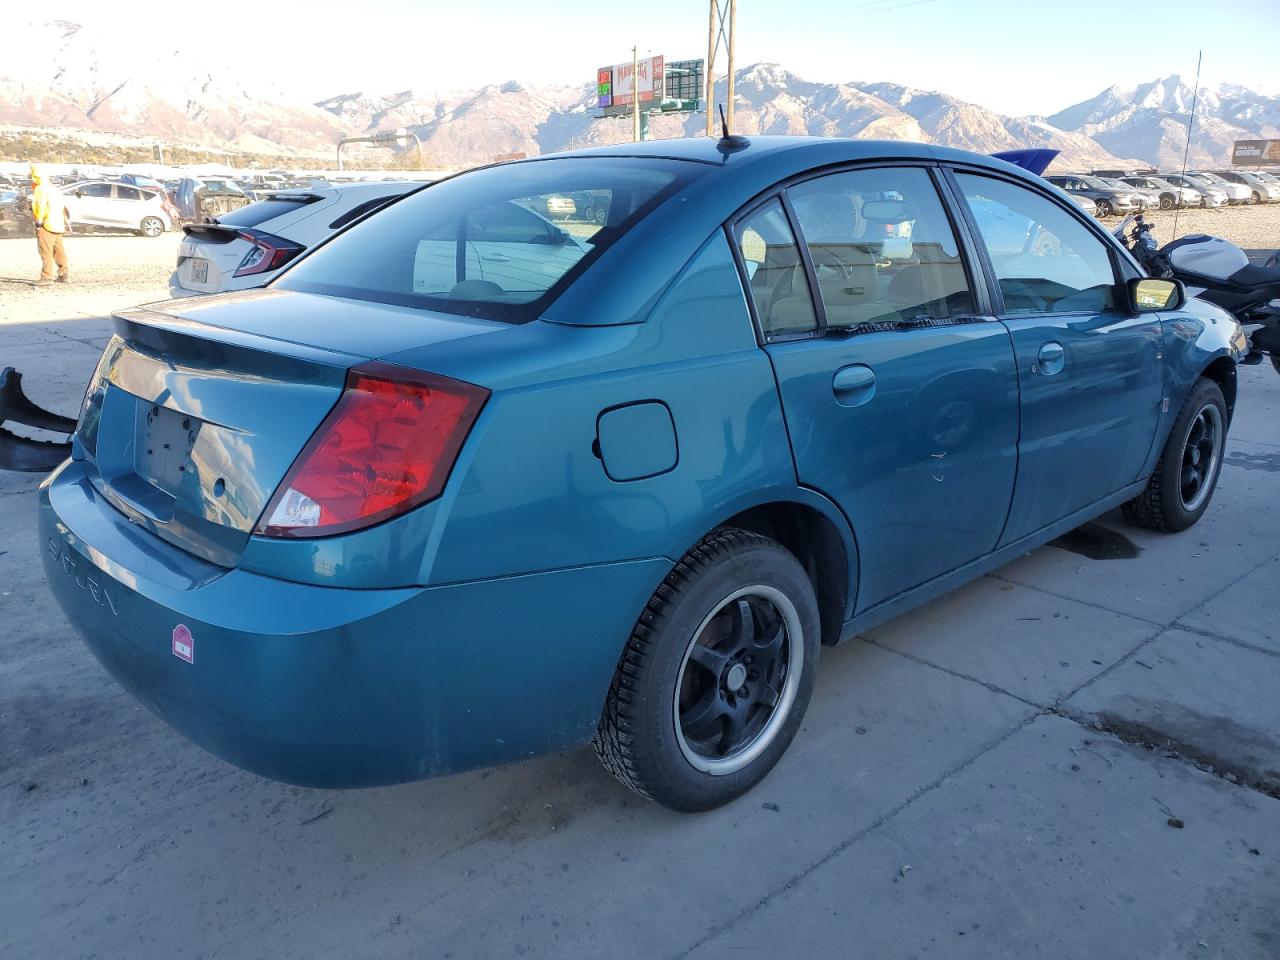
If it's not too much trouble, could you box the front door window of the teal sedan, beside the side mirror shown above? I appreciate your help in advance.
[956,173,1116,316]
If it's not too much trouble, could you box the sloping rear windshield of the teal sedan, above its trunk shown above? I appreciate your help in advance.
[273,156,703,323]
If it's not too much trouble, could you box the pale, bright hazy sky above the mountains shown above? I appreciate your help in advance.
[49,0,1280,114]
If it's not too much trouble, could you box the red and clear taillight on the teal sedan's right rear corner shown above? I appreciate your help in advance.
[255,364,489,536]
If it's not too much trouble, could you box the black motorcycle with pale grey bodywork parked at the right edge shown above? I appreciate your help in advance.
[1115,214,1280,372]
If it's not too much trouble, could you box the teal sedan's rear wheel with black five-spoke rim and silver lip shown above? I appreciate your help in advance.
[594,529,819,813]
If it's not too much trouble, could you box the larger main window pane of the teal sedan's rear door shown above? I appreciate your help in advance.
[787,166,974,329]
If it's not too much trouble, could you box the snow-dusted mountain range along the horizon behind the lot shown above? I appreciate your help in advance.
[0,20,1280,169]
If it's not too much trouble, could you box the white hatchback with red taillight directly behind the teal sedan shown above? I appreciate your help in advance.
[169,180,425,297]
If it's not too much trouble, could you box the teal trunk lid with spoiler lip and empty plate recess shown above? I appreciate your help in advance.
[74,291,509,567]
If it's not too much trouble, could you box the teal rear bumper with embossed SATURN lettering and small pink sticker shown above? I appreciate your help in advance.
[40,461,671,787]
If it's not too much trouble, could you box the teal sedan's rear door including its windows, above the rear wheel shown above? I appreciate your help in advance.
[735,166,1018,612]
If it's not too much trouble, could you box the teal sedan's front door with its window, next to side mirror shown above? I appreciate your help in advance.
[956,173,1164,544]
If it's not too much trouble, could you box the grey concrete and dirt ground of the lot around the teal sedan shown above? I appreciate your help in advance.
[0,209,1280,960]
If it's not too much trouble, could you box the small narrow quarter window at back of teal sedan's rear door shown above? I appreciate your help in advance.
[733,200,818,339]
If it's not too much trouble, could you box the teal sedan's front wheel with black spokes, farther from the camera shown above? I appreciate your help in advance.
[1124,378,1228,534]
